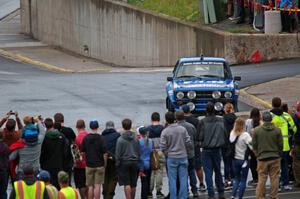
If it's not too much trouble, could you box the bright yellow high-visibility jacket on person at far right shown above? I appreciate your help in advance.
[272,112,297,152]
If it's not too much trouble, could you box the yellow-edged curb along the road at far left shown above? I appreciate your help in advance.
[0,49,75,73]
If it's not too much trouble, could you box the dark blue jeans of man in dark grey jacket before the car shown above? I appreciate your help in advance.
[202,148,224,197]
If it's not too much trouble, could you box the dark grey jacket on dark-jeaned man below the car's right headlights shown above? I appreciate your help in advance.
[197,115,226,149]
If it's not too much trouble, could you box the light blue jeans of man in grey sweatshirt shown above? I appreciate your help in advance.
[167,157,188,199]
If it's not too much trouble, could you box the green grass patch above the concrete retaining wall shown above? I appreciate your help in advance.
[128,0,199,22]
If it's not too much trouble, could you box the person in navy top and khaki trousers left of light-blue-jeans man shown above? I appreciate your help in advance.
[147,112,165,197]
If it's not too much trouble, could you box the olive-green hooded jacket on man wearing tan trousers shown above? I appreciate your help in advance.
[252,122,283,160]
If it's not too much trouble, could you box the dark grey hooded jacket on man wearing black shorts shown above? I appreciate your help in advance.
[116,131,140,166]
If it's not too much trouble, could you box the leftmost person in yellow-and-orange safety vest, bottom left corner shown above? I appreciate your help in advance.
[9,165,49,199]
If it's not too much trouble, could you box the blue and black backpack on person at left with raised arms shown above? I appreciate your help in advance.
[21,124,39,146]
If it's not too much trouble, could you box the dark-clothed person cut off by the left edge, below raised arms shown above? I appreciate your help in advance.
[0,129,9,199]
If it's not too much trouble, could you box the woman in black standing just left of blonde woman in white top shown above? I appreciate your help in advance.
[222,103,237,189]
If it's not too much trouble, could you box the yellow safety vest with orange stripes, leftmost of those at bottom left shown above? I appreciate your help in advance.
[14,180,45,199]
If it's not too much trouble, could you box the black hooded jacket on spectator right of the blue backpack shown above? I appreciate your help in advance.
[40,129,68,170]
